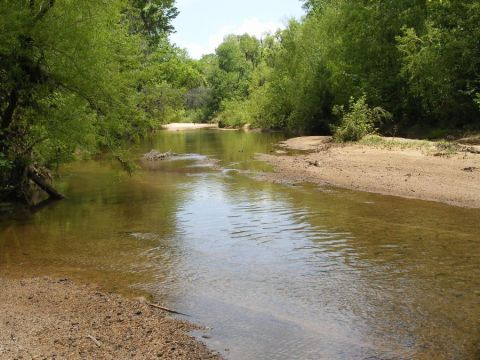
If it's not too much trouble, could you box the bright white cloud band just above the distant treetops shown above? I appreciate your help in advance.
[172,18,285,59]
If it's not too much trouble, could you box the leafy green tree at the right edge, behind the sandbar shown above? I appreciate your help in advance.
[397,1,480,128]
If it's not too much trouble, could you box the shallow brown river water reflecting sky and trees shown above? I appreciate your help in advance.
[0,131,480,359]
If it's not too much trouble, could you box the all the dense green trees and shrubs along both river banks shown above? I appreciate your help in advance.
[0,0,480,199]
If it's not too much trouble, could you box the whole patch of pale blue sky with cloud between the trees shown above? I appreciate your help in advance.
[172,0,303,59]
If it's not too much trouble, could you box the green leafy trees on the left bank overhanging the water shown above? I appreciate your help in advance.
[0,0,204,199]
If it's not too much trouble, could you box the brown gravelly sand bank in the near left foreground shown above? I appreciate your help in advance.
[0,278,218,359]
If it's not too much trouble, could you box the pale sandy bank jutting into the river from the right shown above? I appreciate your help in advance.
[258,137,480,208]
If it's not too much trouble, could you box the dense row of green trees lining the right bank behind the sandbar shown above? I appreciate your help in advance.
[195,0,480,138]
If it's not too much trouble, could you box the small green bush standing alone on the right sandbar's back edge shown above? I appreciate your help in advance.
[332,95,391,142]
